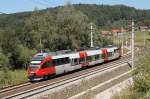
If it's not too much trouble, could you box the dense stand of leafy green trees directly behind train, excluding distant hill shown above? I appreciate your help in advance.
[0,5,108,69]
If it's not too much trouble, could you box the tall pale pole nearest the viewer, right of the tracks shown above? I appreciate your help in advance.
[131,20,134,69]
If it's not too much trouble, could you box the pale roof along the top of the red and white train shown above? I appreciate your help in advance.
[32,45,118,60]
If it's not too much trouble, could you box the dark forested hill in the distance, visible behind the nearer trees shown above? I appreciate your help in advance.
[0,4,150,27]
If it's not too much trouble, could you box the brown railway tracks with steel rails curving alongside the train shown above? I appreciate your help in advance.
[0,55,130,99]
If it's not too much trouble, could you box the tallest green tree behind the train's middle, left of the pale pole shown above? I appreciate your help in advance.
[56,5,89,49]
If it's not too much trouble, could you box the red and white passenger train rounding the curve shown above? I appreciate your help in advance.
[28,46,121,81]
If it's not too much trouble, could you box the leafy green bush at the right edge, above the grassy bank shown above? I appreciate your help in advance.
[134,50,150,93]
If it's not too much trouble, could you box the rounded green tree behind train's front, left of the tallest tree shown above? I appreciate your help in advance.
[22,11,56,49]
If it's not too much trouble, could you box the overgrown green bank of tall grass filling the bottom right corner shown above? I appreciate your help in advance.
[112,49,150,99]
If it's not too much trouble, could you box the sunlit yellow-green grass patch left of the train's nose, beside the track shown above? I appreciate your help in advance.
[0,69,27,88]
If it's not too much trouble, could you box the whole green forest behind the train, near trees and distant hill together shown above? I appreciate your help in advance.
[0,4,150,70]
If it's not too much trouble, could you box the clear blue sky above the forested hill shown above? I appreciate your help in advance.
[0,0,150,13]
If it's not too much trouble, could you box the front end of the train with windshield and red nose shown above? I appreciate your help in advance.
[28,54,44,81]
